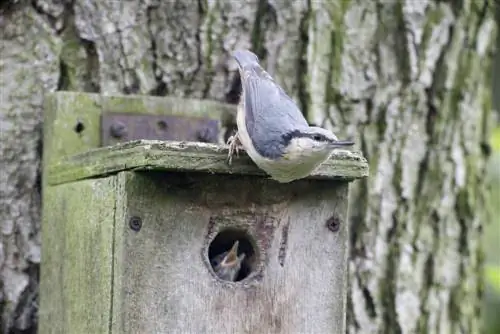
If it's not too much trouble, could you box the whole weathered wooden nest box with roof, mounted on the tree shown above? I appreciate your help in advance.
[39,93,368,334]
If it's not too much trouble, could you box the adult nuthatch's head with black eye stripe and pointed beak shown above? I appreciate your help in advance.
[284,126,354,157]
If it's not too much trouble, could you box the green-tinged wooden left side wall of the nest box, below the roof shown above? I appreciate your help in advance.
[39,177,116,334]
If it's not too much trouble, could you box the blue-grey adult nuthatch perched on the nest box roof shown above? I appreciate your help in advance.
[228,50,354,183]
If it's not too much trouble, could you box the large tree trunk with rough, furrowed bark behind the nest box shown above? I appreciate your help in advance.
[0,0,496,333]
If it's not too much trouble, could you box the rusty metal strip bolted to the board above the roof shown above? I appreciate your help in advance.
[101,112,219,146]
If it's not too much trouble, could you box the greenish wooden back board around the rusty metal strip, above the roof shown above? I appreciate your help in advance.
[44,92,236,164]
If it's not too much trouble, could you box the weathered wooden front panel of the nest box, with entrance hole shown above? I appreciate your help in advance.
[112,172,348,334]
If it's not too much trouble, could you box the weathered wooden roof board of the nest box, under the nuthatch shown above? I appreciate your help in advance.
[48,140,368,185]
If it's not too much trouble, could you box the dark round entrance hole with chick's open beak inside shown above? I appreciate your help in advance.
[208,228,258,282]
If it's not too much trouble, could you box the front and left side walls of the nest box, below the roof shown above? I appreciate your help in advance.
[39,166,354,334]
